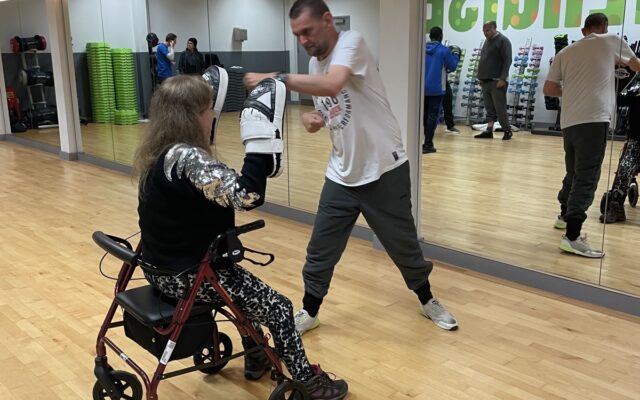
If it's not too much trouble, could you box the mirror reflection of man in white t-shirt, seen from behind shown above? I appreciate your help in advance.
[543,13,640,258]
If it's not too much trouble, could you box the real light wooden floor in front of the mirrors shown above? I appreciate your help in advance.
[0,142,640,400]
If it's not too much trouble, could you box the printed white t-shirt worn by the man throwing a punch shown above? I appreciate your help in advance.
[309,31,407,186]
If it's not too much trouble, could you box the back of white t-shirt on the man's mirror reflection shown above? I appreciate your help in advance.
[547,33,635,129]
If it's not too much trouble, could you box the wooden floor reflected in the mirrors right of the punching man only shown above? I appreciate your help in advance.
[421,126,640,295]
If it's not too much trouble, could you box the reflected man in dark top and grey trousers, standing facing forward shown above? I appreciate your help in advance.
[474,21,513,140]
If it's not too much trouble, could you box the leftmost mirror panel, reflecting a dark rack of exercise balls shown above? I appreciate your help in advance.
[0,0,60,149]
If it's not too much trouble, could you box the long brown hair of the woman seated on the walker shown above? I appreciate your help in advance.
[133,75,213,185]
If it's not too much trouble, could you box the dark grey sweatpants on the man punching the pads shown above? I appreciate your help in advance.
[302,162,433,299]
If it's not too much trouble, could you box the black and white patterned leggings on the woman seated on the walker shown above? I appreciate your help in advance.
[145,265,313,382]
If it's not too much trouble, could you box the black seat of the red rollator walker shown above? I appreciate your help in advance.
[116,285,214,327]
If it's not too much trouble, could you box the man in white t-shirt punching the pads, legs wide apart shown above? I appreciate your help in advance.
[245,0,458,333]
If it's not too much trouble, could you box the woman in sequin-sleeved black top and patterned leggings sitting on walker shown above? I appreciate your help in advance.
[134,75,347,399]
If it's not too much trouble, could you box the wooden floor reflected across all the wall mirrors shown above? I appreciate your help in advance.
[8,105,640,296]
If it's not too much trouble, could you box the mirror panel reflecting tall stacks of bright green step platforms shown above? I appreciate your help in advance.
[69,0,150,166]
